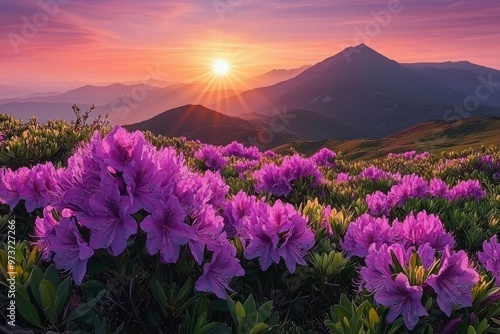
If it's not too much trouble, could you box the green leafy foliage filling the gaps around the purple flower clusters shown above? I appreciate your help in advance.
[0,114,500,334]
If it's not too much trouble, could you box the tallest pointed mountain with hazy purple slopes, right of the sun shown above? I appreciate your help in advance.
[216,44,484,136]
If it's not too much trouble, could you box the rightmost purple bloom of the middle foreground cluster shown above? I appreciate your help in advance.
[278,214,315,273]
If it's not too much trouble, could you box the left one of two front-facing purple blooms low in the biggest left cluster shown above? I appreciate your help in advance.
[77,181,137,256]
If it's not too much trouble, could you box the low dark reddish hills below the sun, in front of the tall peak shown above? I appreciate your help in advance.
[125,104,366,148]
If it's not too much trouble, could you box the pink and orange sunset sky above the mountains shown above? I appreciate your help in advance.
[0,0,500,84]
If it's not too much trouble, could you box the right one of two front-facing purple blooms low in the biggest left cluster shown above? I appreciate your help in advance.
[141,196,196,263]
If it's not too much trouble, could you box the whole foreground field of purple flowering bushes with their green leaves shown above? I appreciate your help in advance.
[0,117,500,333]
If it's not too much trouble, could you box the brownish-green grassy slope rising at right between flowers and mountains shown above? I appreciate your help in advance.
[275,117,500,160]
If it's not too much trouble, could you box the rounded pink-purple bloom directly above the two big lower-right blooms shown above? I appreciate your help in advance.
[403,211,455,251]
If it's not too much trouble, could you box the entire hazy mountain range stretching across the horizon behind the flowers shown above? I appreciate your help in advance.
[0,44,500,145]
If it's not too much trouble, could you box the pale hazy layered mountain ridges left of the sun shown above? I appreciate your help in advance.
[0,84,239,125]
